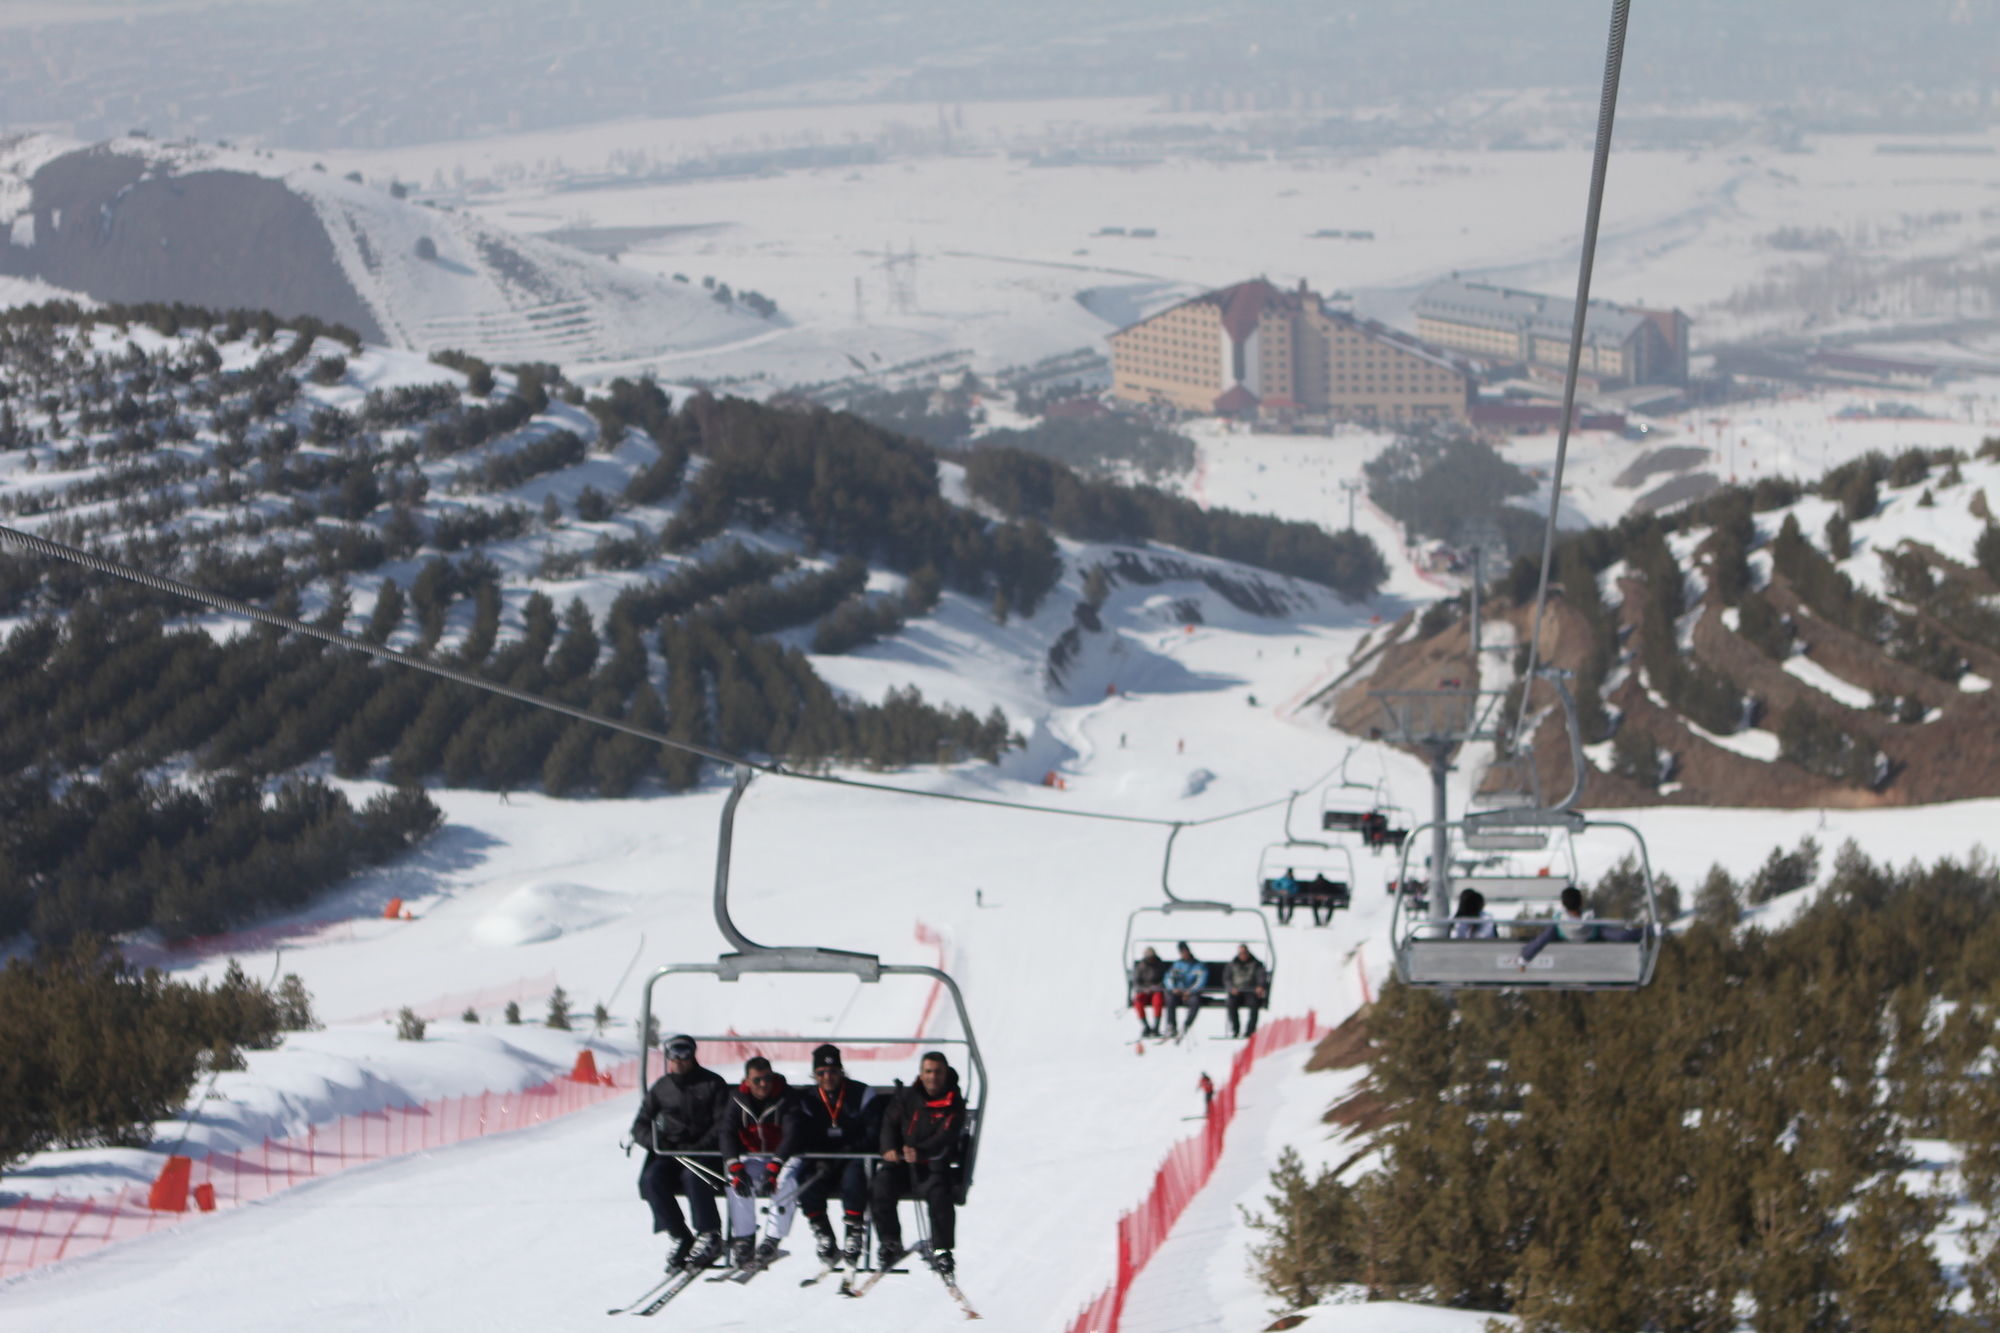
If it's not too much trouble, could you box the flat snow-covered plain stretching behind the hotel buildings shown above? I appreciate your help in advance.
[312,98,2000,386]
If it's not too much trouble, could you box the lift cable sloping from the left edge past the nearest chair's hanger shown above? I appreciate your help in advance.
[0,524,1324,829]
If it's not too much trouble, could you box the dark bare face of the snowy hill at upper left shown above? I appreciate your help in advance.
[0,148,382,340]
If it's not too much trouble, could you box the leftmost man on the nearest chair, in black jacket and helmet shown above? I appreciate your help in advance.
[632,1035,730,1271]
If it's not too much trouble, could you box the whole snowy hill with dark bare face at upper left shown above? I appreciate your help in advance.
[0,134,784,364]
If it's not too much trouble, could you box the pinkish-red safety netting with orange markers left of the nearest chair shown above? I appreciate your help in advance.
[0,1053,638,1279]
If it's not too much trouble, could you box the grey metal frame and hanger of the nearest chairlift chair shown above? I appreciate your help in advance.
[638,767,988,1203]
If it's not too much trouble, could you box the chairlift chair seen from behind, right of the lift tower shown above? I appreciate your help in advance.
[1390,811,1660,991]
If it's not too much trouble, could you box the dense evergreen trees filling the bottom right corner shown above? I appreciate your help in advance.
[1256,845,2000,1333]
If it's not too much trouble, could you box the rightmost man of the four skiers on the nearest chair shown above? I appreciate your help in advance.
[872,1051,966,1279]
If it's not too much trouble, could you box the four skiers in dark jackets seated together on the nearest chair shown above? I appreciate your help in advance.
[632,1035,966,1279]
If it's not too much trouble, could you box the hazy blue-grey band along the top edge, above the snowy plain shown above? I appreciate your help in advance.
[0,0,2000,148]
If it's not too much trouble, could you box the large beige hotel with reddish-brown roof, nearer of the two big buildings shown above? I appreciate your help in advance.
[1110,278,1472,422]
